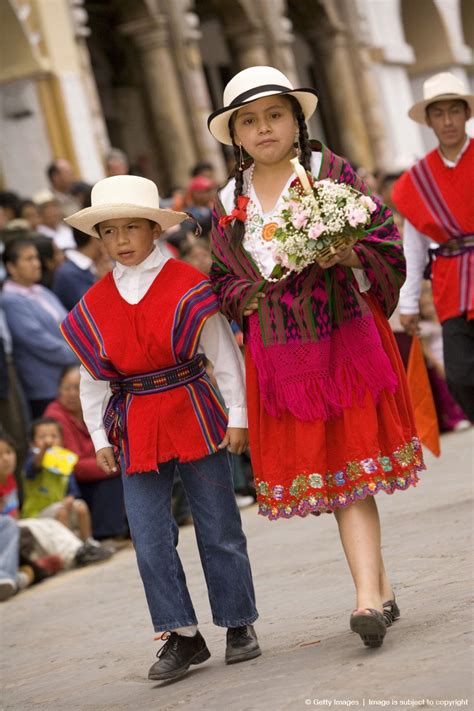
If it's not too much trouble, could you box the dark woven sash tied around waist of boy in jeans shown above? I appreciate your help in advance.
[104,354,206,446]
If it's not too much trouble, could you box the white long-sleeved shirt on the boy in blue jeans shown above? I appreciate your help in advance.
[81,248,247,451]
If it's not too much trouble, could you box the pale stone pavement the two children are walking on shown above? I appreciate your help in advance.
[0,430,474,711]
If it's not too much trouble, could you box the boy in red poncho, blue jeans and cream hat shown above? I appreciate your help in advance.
[62,175,261,680]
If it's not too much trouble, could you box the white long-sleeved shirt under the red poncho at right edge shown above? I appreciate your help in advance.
[400,136,470,315]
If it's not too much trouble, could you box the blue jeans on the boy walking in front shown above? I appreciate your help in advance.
[123,450,258,632]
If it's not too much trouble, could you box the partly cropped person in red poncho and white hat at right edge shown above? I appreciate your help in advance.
[392,72,474,422]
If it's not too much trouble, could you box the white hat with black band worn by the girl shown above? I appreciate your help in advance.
[207,67,318,146]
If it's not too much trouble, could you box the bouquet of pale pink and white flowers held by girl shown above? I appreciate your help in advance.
[272,159,377,279]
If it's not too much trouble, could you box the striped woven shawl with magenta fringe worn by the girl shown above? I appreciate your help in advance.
[210,143,405,420]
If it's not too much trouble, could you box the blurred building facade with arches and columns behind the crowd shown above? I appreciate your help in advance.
[0,0,474,195]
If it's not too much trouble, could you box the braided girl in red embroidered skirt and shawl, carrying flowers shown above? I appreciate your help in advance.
[208,67,424,647]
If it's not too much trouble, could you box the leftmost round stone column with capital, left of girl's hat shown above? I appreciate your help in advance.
[120,15,197,191]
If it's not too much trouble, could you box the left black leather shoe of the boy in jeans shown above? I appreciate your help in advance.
[148,631,211,681]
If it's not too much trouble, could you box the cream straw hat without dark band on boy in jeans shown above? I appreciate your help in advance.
[64,175,189,237]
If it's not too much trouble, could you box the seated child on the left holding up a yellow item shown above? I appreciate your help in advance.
[22,417,92,541]
